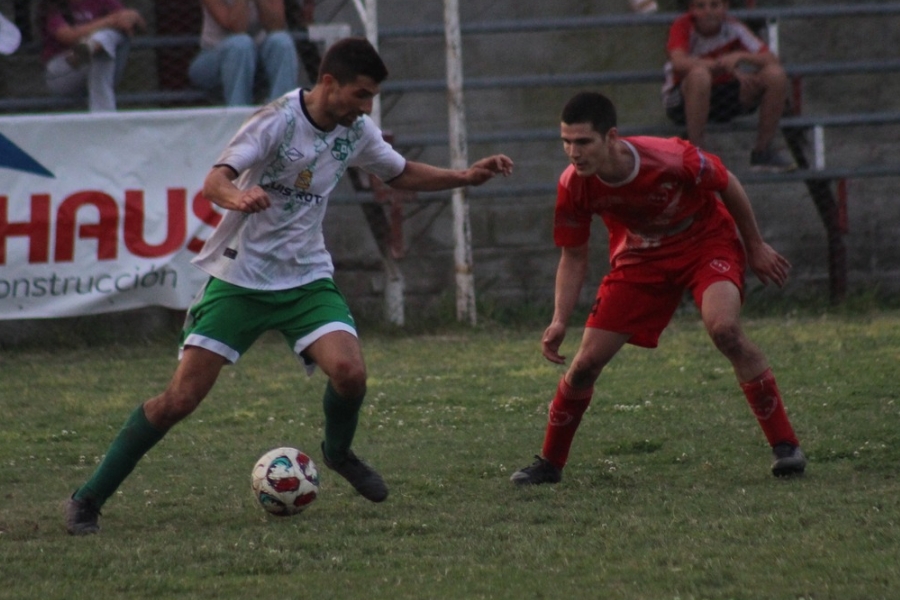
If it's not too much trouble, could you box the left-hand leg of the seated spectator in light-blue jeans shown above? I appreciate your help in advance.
[188,33,256,106]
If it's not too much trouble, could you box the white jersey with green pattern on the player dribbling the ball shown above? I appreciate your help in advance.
[198,90,406,290]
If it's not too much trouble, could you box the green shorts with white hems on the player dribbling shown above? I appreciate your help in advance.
[179,277,356,372]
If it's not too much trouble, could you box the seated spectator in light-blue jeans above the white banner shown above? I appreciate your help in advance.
[188,0,299,106]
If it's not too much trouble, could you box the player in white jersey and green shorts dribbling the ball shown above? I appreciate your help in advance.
[65,38,513,535]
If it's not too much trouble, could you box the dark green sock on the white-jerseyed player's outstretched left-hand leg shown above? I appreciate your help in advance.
[74,405,166,507]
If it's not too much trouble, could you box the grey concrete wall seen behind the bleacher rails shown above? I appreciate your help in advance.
[316,0,900,324]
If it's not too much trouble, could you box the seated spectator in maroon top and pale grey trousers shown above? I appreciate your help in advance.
[38,0,146,112]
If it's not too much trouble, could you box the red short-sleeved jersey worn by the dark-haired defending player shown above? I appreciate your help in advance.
[553,137,737,267]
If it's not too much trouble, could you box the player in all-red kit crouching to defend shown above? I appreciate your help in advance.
[511,92,806,485]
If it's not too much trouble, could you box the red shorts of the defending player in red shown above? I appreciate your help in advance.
[586,238,747,348]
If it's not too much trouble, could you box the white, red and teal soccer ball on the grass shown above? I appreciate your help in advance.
[250,448,319,517]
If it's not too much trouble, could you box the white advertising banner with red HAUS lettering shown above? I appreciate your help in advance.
[0,108,251,319]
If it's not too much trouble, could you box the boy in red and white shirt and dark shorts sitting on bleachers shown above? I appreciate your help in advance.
[663,0,796,171]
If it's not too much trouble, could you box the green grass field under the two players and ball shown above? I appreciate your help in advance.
[0,311,900,600]
